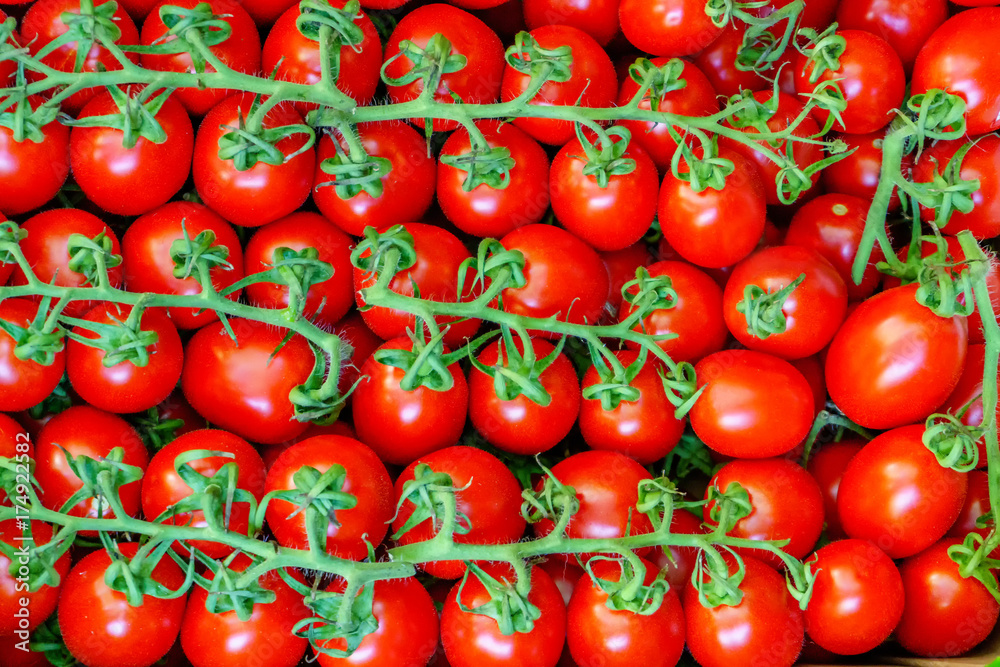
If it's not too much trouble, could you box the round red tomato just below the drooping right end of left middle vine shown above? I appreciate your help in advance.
[265,435,393,560]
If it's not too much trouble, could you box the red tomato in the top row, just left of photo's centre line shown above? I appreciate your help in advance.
[382,3,504,132]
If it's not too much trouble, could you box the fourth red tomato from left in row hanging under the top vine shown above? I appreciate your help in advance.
[313,122,436,236]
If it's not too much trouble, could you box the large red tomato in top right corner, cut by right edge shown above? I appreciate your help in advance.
[910,7,1000,136]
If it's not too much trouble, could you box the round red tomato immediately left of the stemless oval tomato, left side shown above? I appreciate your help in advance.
[66,302,184,413]
